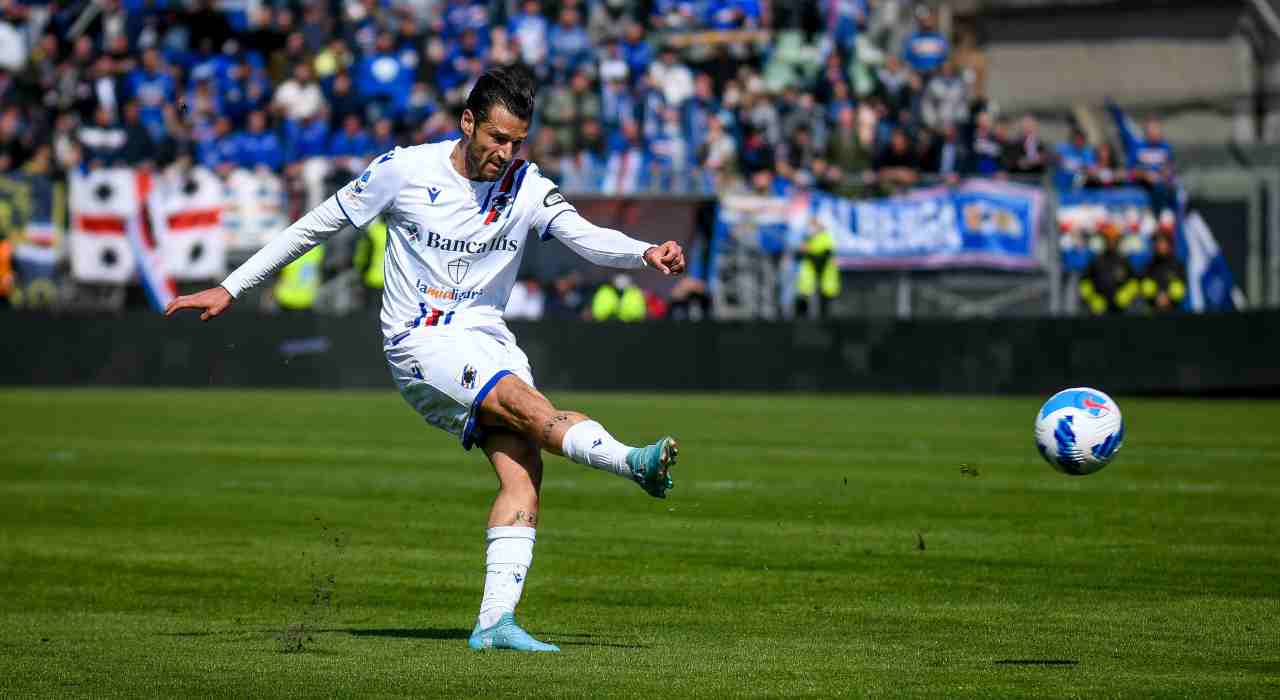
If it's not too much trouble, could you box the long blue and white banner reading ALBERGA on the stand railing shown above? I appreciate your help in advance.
[718,180,1043,270]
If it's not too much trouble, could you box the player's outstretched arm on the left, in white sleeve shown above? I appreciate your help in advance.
[164,148,404,321]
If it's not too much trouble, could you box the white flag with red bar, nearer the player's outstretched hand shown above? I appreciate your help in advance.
[152,168,227,282]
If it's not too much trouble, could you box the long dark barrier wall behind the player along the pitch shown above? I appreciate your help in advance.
[0,312,1280,394]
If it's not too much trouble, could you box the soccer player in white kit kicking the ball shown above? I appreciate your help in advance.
[165,67,685,651]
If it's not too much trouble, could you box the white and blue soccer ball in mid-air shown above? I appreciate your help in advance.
[1036,386,1124,476]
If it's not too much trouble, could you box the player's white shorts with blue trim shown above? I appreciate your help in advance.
[385,326,534,449]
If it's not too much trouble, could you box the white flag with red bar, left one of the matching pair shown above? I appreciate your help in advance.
[70,168,141,284]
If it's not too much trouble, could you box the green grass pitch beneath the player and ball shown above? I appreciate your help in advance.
[0,389,1280,697]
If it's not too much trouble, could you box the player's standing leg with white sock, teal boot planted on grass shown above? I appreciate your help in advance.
[468,430,559,651]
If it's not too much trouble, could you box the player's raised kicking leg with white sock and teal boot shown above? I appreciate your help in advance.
[479,375,680,498]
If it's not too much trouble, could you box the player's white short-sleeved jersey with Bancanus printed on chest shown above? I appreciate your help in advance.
[337,141,573,344]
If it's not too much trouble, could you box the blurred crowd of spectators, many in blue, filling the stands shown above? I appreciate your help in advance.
[0,0,1172,317]
